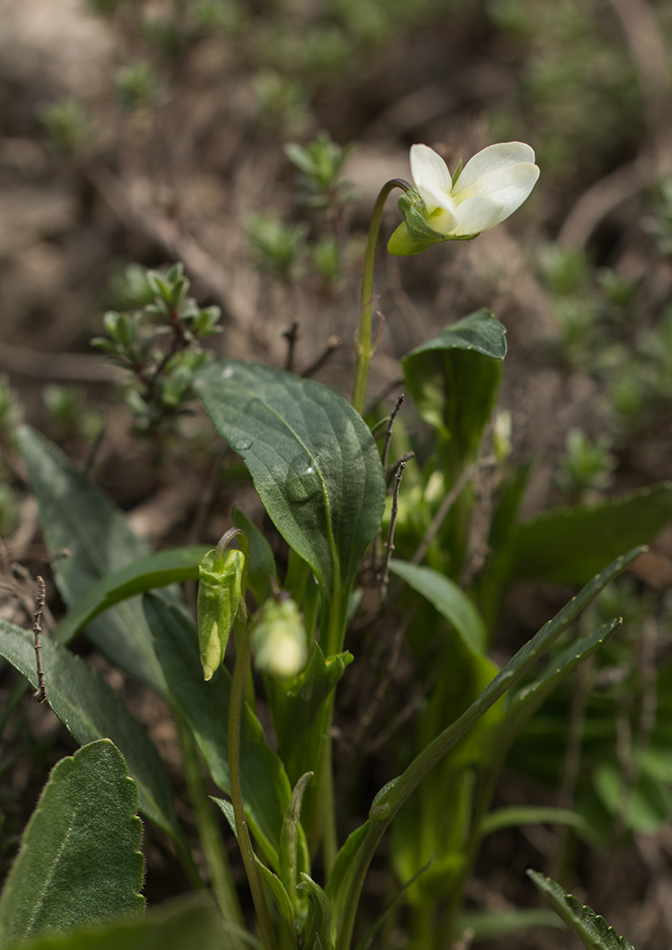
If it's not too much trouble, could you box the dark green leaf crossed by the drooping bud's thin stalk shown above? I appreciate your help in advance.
[144,594,291,868]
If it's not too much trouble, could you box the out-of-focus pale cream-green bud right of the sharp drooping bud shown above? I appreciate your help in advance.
[252,597,308,678]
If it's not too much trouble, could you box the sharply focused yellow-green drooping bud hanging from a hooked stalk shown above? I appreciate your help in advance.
[196,548,245,680]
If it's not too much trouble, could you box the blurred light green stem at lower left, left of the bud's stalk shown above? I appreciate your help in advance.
[173,710,244,932]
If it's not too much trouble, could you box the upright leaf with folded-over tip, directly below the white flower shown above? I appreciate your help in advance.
[402,310,506,466]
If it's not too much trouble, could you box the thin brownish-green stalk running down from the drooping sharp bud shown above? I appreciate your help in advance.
[229,621,276,950]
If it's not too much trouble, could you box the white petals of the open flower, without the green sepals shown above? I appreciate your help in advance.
[411,142,539,238]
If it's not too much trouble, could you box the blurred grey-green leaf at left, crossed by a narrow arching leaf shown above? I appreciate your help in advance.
[19,426,165,692]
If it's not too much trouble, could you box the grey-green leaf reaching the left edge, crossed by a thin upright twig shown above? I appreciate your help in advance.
[0,620,186,848]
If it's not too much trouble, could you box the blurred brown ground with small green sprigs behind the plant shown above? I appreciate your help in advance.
[0,0,672,947]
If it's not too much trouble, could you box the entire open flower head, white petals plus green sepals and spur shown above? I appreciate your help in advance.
[387,142,539,256]
